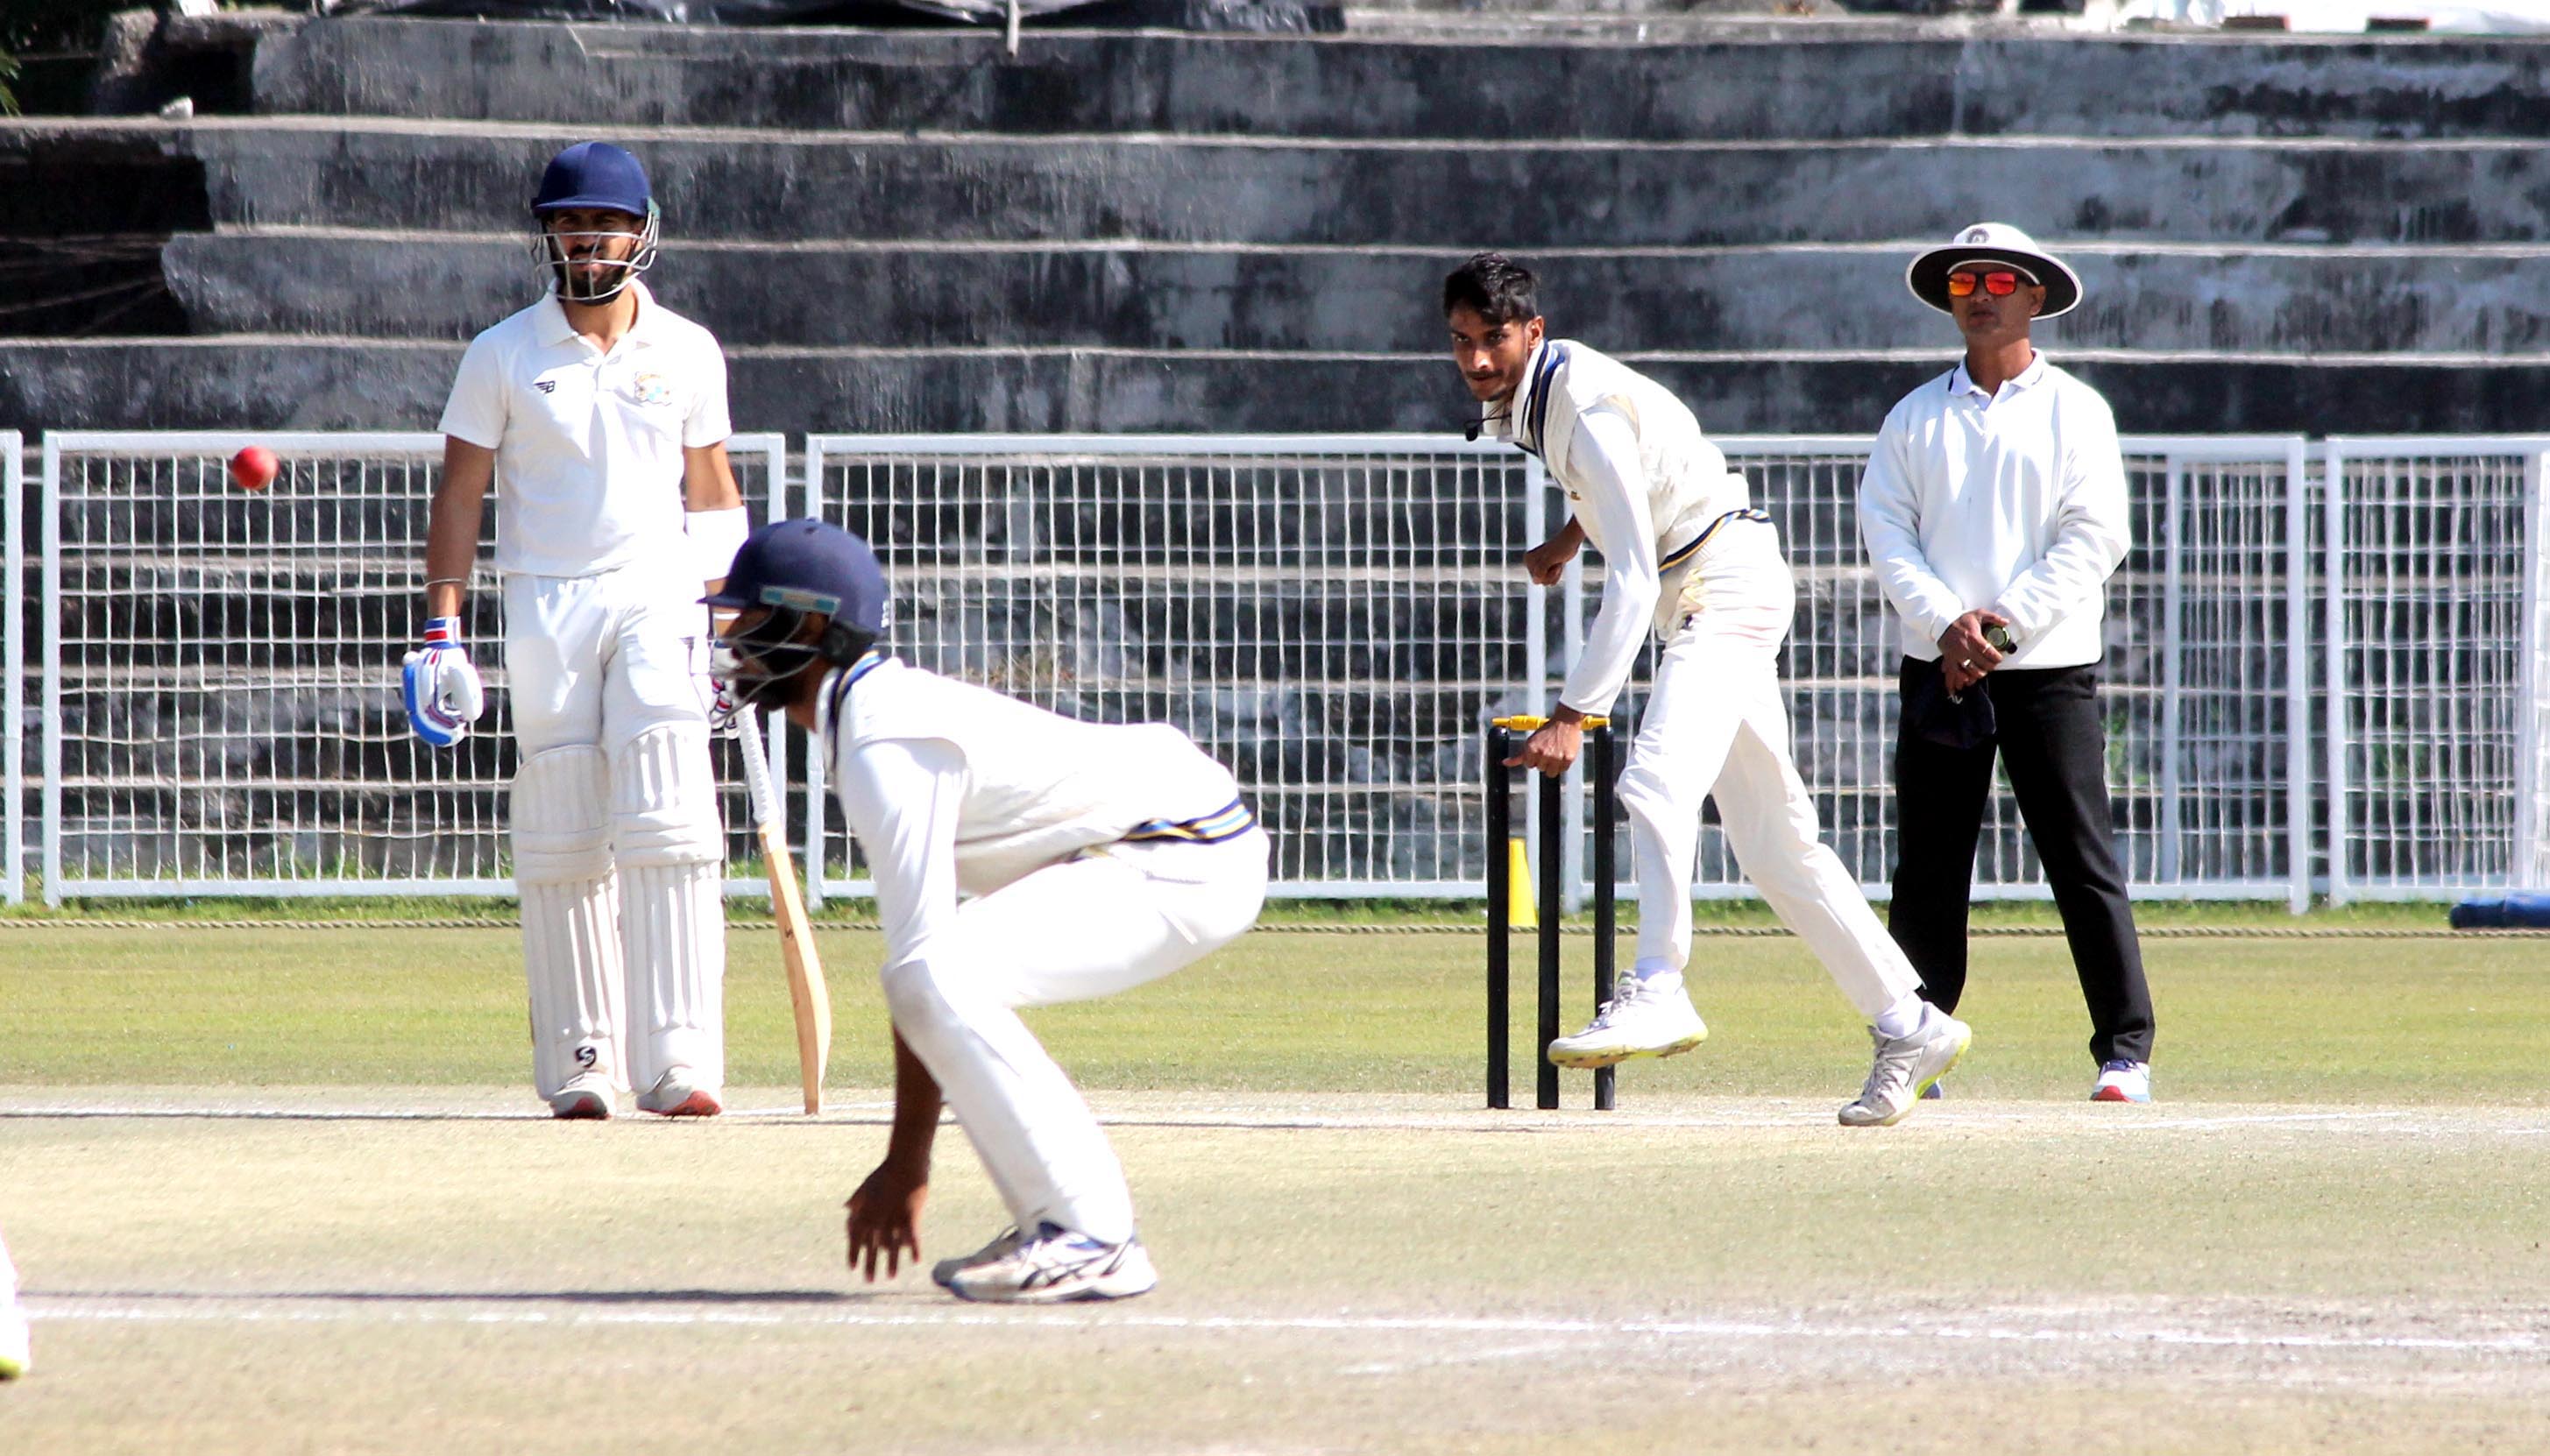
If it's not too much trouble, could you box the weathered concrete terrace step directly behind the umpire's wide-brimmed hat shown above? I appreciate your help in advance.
[163,230,2550,355]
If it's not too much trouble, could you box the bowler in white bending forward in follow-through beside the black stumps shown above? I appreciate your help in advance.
[1443,252,1971,1127]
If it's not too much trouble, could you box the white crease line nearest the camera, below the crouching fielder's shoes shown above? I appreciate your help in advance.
[23,1296,2550,1354]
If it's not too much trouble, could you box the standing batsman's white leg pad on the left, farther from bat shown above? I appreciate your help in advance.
[513,745,627,1099]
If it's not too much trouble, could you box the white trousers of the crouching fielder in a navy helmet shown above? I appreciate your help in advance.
[885,829,1267,1244]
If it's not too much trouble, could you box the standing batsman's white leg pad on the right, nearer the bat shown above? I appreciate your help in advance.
[612,724,726,1092]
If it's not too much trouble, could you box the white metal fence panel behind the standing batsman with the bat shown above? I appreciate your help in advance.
[32,434,785,902]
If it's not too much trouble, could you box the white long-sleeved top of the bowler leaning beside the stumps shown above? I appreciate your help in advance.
[1482,339,1752,714]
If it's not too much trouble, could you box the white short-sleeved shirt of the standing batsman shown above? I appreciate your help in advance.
[441,283,732,576]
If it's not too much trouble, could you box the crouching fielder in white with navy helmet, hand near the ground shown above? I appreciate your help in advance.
[709,520,1267,1303]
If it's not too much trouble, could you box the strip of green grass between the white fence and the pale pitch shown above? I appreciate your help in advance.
[0,923,2550,1106]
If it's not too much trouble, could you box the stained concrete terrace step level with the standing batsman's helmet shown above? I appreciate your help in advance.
[0,117,2550,250]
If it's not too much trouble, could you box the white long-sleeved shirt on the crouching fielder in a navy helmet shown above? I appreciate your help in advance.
[824,658,1239,961]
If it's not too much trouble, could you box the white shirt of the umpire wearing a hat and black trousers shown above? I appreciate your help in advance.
[1859,352,2132,668]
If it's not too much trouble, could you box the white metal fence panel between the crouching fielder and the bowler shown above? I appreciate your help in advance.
[806,436,1550,898]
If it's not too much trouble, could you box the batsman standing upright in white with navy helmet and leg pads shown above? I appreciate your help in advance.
[406,143,745,1117]
